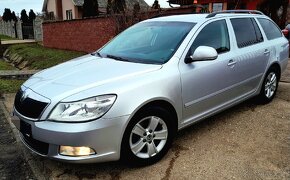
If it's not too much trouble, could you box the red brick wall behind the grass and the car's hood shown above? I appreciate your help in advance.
[43,17,116,52]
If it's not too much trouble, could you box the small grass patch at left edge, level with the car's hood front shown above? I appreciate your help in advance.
[0,79,25,94]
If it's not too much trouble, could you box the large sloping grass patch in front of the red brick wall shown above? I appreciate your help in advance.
[9,44,85,69]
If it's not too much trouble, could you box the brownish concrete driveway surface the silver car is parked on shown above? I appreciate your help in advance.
[1,83,290,180]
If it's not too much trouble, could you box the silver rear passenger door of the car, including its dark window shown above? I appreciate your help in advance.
[230,17,271,94]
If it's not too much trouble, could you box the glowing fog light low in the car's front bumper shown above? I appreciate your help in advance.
[59,146,96,156]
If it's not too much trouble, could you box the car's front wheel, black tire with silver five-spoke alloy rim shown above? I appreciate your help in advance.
[121,106,176,166]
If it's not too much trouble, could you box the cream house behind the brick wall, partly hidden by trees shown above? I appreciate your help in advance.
[42,0,149,20]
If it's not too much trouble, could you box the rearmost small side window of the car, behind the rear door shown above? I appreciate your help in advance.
[258,18,282,40]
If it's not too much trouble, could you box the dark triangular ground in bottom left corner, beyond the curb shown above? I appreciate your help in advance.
[0,102,35,180]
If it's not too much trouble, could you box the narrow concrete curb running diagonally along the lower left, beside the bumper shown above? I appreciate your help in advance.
[0,97,47,180]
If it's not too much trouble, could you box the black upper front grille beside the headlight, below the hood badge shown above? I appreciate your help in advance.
[14,89,48,119]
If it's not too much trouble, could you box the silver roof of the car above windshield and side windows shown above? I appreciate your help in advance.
[146,13,267,23]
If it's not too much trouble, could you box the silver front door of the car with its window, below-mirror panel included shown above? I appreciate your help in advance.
[179,19,240,125]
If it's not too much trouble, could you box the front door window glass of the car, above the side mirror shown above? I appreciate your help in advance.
[191,20,230,53]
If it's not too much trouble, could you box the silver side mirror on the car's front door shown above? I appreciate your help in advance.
[185,46,218,64]
